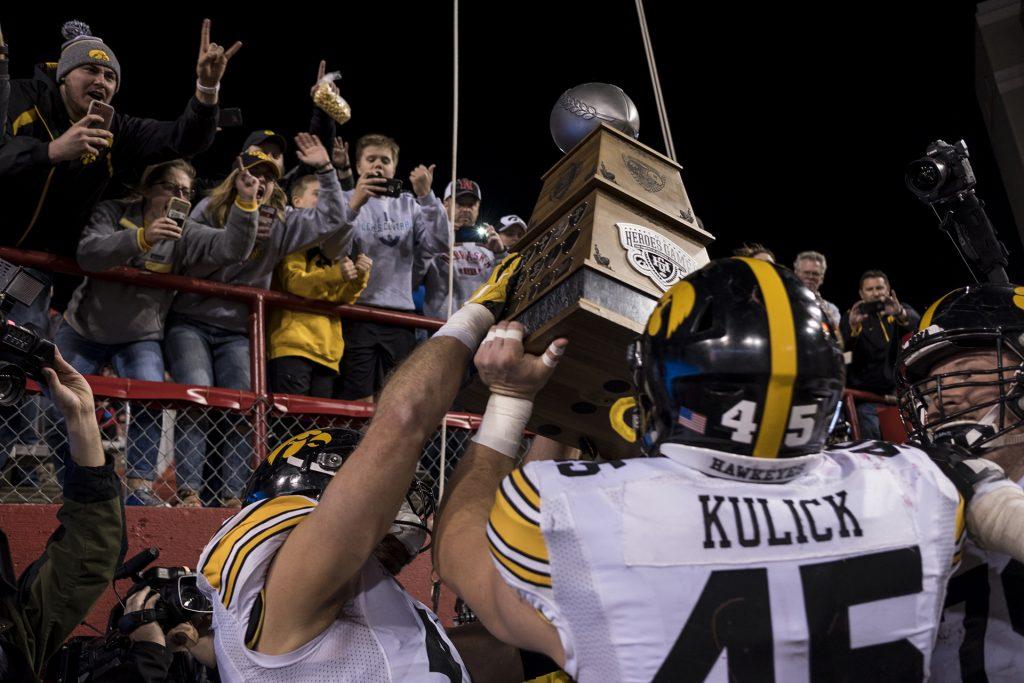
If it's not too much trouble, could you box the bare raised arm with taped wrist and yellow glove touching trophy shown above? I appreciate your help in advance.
[258,259,518,654]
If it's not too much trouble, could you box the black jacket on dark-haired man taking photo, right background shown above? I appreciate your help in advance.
[843,304,921,395]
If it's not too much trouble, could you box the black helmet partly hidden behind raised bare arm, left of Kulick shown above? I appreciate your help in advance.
[242,429,436,554]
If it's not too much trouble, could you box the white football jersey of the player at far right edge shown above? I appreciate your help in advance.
[932,481,1024,683]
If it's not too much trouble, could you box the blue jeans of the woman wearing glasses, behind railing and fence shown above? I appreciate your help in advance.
[54,323,164,481]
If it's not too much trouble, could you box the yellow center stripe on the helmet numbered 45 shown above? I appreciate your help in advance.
[739,258,797,458]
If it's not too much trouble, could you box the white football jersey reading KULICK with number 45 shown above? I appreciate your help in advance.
[487,442,964,683]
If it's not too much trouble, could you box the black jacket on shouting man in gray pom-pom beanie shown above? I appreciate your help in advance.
[0,63,218,256]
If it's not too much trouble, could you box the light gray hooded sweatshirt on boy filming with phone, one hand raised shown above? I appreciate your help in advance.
[343,193,449,310]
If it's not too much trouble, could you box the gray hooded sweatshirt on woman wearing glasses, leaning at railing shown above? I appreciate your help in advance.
[65,200,258,344]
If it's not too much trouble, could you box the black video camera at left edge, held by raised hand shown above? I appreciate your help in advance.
[0,258,53,405]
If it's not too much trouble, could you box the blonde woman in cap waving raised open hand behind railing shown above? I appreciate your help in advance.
[164,133,351,505]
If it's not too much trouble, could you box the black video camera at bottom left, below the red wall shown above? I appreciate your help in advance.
[54,548,213,683]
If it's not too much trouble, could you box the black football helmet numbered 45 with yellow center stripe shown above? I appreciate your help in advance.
[631,258,845,458]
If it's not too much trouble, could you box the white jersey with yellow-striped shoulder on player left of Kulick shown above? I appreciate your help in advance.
[198,496,470,683]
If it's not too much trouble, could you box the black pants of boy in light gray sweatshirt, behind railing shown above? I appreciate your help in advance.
[334,321,416,400]
